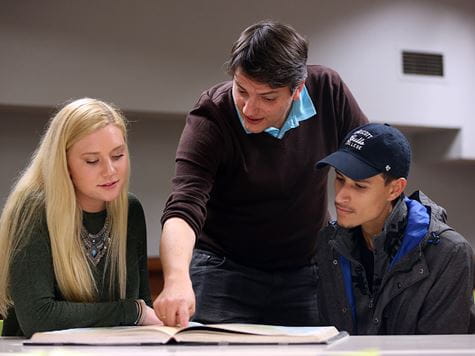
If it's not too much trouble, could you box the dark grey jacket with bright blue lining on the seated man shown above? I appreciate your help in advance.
[317,192,474,334]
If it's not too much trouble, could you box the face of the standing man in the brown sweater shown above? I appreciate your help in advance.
[233,68,304,133]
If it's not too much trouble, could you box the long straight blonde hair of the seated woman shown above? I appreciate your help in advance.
[0,98,129,317]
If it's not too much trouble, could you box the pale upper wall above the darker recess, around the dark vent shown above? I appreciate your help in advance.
[0,0,475,145]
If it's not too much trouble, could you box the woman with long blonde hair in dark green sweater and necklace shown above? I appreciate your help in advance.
[0,98,160,337]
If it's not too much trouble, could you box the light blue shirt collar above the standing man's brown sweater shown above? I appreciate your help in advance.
[234,86,317,139]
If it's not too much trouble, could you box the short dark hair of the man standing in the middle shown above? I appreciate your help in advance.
[227,21,308,92]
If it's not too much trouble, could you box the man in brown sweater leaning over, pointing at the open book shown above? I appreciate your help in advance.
[154,18,367,325]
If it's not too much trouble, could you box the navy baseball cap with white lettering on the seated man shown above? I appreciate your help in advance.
[316,124,411,180]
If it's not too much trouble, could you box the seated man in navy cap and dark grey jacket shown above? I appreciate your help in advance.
[317,124,474,334]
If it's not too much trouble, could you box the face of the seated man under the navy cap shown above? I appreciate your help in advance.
[335,171,403,228]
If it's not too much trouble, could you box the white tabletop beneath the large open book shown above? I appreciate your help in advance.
[0,335,475,356]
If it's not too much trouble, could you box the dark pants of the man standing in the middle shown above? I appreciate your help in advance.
[190,250,319,326]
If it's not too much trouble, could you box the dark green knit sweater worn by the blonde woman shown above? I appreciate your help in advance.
[2,195,151,337]
